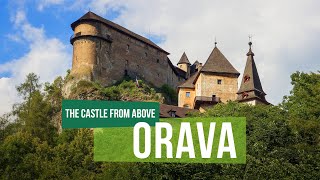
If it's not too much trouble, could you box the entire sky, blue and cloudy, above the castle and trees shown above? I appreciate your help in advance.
[0,0,320,115]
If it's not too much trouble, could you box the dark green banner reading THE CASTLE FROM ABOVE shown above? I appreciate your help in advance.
[62,100,159,128]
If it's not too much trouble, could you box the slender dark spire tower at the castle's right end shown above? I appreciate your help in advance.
[237,41,270,105]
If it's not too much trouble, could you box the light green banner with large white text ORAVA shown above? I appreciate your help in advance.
[94,117,246,164]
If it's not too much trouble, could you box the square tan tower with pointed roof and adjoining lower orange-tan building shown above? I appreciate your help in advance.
[178,43,240,111]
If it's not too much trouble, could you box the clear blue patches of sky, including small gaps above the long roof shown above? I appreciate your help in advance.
[0,0,164,77]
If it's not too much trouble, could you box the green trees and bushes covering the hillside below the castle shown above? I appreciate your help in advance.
[0,72,320,179]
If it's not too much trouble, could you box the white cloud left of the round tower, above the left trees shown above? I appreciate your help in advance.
[0,12,71,115]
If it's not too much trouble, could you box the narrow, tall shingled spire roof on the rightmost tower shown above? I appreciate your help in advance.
[238,43,266,95]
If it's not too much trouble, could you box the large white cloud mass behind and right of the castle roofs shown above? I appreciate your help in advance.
[90,0,320,104]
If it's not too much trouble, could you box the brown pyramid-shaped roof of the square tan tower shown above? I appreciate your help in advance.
[201,47,240,76]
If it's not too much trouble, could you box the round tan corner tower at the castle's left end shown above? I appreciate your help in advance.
[70,12,112,80]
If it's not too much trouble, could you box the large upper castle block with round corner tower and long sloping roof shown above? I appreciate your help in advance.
[70,12,186,88]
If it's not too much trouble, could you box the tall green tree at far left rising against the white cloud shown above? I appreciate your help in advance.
[14,73,56,143]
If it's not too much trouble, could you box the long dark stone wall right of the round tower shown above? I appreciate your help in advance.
[90,23,183,88]
